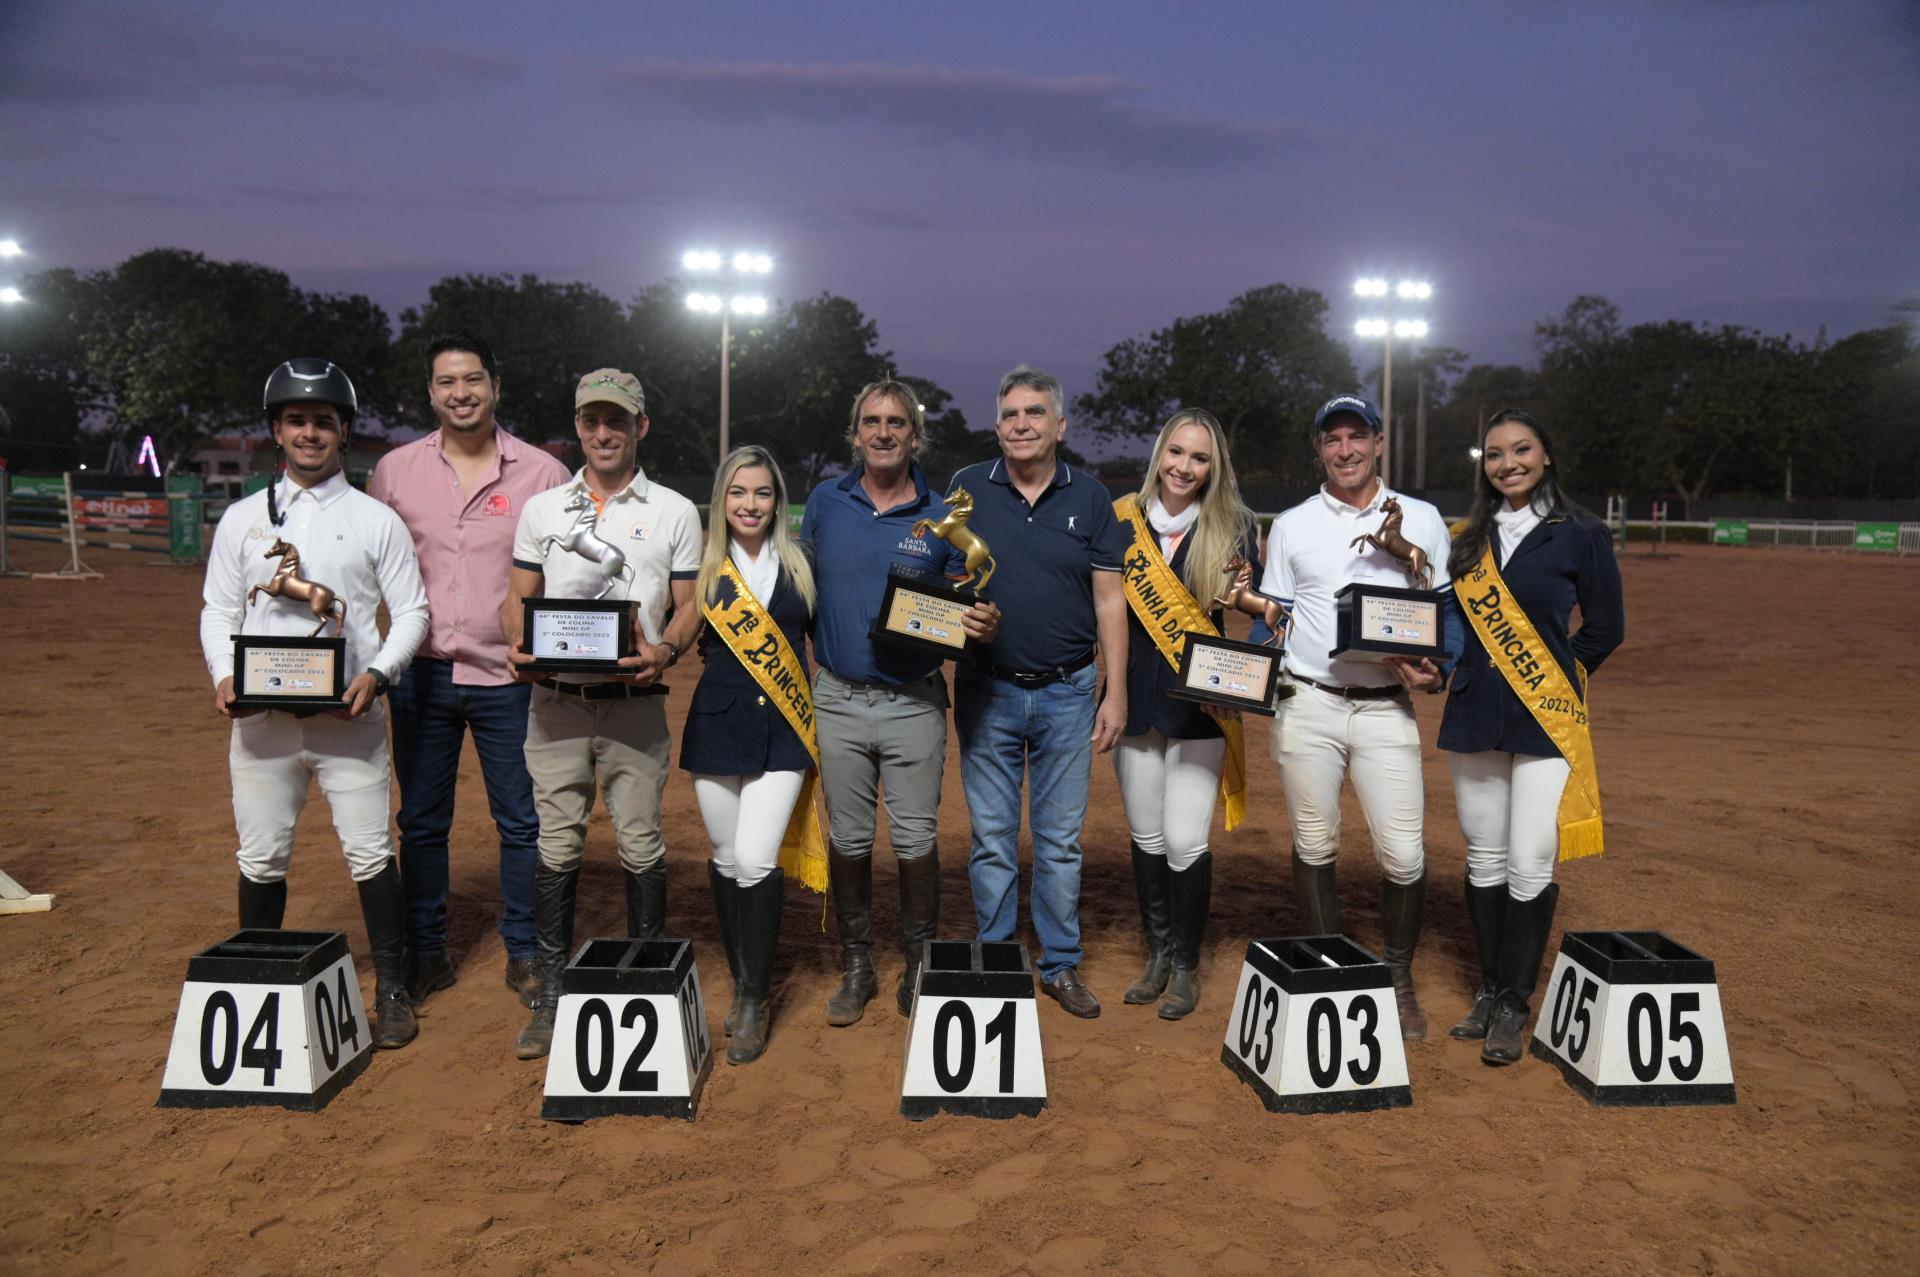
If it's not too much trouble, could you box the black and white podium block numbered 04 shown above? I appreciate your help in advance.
[159,931,372,1112]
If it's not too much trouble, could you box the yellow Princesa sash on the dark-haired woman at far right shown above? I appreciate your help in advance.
[1453,538,1603,860]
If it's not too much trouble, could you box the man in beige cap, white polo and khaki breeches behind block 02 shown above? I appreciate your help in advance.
[501,369,703,1060]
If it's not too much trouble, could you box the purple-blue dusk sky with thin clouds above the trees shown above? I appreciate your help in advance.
[0,0,1920,421]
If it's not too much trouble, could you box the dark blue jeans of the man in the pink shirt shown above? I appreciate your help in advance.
[390,657,540,958]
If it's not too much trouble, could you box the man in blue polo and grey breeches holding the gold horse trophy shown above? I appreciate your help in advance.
[801,380,1000,1025]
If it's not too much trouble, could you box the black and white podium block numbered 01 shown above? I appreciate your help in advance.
[900,941,1046,1121]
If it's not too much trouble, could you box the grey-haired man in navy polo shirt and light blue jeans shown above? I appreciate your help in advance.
[947,365,1127,1020]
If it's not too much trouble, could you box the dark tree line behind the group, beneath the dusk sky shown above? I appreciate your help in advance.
[0,248,1920,507]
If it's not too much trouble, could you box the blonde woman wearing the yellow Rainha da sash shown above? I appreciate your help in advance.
[1114,409,1261,1020]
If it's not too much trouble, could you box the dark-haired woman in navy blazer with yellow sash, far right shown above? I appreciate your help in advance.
[1438,409,1626,1064]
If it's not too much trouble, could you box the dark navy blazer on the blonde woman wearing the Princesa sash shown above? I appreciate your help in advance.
[680,568,814,776]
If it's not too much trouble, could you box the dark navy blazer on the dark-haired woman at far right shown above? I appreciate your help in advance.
[1438,518,1626,759]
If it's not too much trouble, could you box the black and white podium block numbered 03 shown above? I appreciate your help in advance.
[1219,935,1413,1114]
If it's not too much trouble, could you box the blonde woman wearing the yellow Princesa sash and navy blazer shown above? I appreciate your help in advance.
[680,447,826,1064]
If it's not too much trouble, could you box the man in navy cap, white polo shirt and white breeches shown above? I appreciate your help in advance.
[1260,396,1448,1041]
